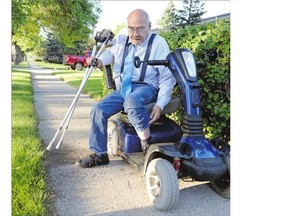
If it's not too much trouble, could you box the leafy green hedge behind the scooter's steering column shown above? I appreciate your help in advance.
[160,20,230,142]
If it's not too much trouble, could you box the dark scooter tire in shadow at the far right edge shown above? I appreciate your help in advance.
[210,155,230,199]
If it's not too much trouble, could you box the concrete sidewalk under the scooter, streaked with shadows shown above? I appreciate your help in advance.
[30,63,230,216]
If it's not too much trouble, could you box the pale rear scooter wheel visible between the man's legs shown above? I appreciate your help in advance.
[107,121,119,156]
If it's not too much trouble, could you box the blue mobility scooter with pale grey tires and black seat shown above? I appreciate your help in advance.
[106,44,230,211]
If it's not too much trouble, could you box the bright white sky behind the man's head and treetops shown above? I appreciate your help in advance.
[96,0,230,31]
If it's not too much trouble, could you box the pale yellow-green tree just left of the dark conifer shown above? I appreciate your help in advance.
[157,0,176,28]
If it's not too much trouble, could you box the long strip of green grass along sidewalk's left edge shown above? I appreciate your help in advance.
[11,71,47,215]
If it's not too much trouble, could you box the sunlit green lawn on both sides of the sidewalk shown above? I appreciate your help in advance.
[11,62,112,215]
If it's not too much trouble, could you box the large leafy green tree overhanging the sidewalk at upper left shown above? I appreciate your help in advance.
[12,0,101,63]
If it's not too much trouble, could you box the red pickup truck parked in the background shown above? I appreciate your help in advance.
[63,50,92,70]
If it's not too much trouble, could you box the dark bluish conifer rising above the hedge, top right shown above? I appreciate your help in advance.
[175,0,206,26]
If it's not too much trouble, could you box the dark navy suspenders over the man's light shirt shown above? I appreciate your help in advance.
[120,33,156,83]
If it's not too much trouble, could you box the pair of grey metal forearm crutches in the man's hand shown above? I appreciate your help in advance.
[46,29,114,151]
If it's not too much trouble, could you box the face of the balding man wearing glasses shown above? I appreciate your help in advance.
[128,13,151,46]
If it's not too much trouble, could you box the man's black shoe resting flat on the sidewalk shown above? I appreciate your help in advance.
[76,153,109,168]
